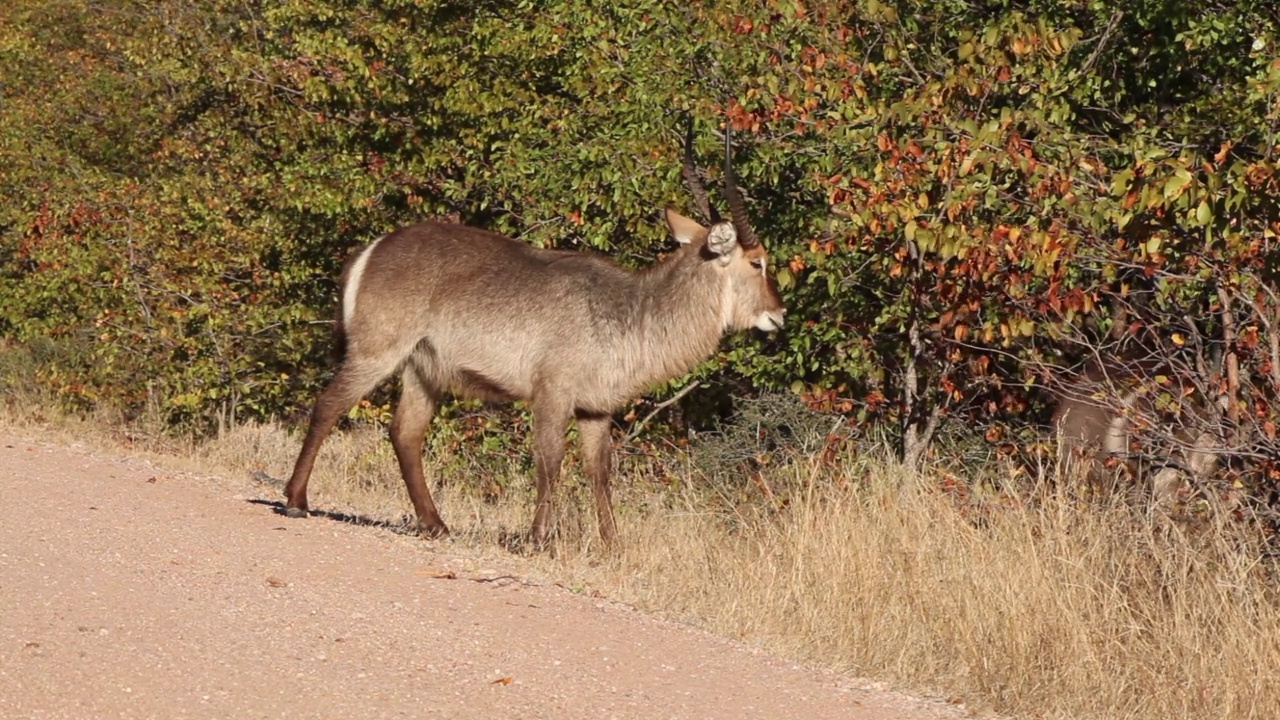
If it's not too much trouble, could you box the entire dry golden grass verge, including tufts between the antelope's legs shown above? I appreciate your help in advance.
[5,394,1280,720]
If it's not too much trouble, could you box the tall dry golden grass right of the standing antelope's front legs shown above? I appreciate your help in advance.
[620,466,1280,717]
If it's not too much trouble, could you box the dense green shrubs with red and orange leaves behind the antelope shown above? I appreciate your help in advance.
[0,0,1280,484]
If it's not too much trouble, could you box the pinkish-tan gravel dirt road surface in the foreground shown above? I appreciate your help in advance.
[0,429,966,720]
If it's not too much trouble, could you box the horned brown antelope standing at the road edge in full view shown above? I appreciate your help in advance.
[284,131,786,544]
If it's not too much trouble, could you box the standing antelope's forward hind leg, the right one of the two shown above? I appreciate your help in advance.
[390,359,449,538]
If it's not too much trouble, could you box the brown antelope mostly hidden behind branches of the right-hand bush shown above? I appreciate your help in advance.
[1052,366,1222,503]
